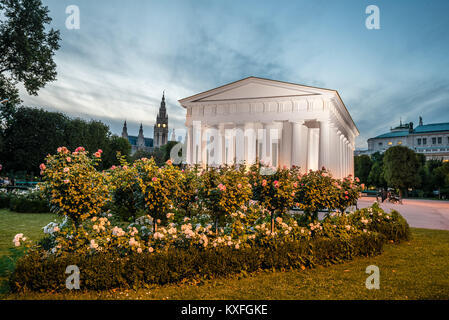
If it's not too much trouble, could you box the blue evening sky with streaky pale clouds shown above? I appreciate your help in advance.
[15,0,449,148]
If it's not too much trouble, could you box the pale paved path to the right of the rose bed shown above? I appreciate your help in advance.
[358,197,449,230]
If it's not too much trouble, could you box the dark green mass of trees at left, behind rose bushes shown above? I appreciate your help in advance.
[0,107,131,174]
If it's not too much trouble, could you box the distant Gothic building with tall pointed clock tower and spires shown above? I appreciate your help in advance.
[122,93,174,154]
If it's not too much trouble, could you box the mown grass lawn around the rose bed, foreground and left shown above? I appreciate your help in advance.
[0,211,449,300]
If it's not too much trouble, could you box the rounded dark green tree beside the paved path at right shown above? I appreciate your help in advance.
[383,146,421,196]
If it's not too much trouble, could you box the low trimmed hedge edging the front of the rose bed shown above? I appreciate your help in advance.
[9,233,385,291]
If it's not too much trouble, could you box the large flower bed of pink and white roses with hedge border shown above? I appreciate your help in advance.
[10,147,408,290]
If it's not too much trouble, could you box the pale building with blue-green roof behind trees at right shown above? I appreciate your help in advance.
[366,117,449,161]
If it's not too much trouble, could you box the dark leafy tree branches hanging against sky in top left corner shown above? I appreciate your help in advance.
[0,0,60,101]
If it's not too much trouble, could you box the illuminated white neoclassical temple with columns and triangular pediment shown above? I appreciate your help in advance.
[179,77,359,178]
